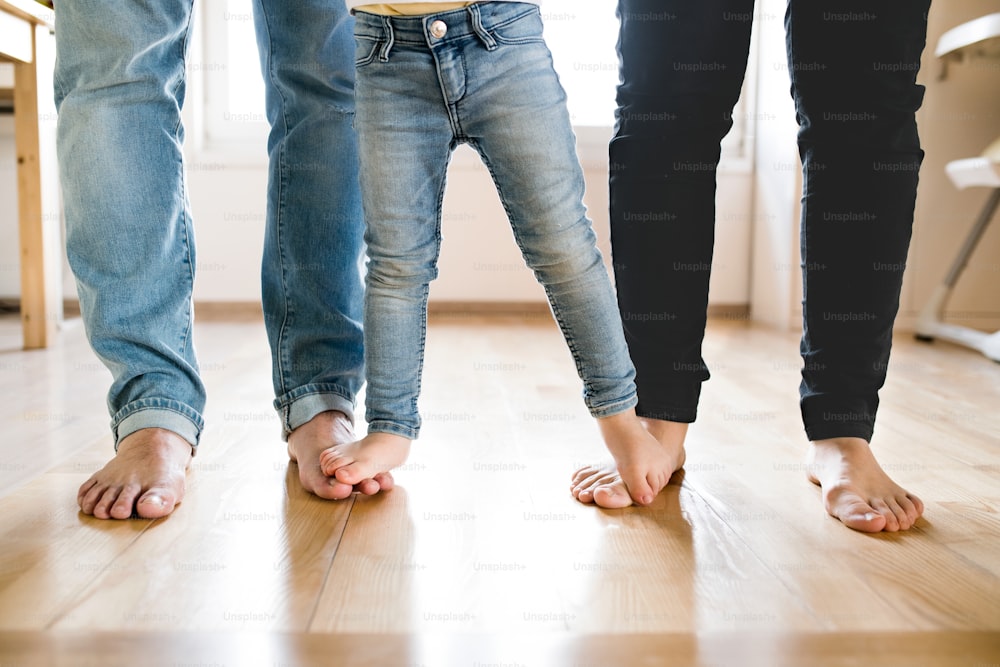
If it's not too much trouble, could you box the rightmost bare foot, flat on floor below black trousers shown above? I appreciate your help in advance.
[806,438,924,533]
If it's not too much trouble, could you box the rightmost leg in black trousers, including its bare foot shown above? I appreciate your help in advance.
[786,0,929,532]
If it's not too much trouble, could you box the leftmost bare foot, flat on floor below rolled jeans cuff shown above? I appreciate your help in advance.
[76,428,191,519]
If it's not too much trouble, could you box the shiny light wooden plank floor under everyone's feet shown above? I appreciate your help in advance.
[0,315,1000,667]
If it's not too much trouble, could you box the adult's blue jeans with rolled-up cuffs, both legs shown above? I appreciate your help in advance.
[55,0,363,446]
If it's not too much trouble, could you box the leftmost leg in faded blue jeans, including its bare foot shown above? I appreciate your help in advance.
[55,0,205,519]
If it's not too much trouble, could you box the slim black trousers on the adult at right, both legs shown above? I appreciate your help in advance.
[610,0,930,440]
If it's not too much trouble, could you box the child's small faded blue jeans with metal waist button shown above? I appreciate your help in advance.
[355,2,636,439]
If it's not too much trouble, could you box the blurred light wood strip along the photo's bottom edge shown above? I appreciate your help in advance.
[0,632,1000,667]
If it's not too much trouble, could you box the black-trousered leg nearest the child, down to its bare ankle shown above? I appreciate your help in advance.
[610,0,753,451]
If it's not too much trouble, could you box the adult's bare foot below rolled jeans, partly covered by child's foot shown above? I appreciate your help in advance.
[288,411,394,500]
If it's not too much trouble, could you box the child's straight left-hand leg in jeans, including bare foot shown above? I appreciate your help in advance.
[321,14,453,491]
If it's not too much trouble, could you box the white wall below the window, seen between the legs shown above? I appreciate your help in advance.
[0,59,751,305]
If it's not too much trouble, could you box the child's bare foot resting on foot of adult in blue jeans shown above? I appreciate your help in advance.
[319,432,410,495]
